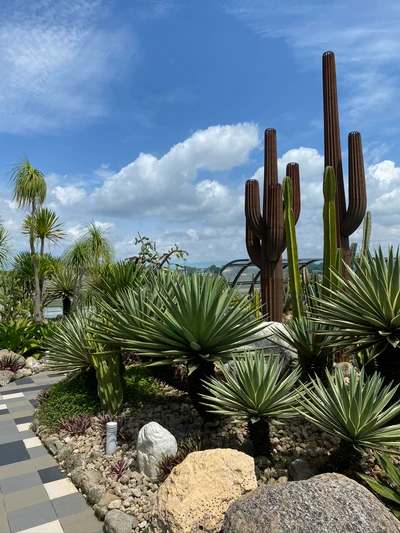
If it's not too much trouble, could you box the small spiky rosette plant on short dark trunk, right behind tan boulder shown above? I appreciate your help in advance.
[202,352,299,456]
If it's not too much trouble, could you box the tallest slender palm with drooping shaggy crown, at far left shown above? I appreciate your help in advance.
[10,158,47,322]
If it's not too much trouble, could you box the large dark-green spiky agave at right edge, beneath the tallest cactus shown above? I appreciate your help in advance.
[313,247,400,384]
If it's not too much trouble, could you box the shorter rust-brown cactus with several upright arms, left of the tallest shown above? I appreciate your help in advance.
[245,128,300,322]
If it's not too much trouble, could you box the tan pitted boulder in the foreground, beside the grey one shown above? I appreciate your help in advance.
[150,449,257,533]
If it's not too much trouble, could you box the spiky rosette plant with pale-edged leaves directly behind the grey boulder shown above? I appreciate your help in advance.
[298,368,400,472]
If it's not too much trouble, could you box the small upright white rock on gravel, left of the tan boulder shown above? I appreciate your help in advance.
[137,422,178,479]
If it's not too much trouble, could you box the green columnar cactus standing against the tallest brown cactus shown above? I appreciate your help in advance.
[322,167,337,289]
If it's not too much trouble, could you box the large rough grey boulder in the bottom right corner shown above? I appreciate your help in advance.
[222,474,400,533]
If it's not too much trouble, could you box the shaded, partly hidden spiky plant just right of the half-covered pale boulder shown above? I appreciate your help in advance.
[272,317,334,382]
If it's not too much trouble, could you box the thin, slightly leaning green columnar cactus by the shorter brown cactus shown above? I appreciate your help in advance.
[283,176,304,318]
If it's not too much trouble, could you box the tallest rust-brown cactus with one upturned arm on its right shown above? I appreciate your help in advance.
[322,52,367,264]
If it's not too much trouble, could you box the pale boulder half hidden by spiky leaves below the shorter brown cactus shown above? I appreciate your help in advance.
[225,322,298,370]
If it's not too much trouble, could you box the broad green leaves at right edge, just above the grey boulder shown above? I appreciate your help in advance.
[360,452,400,518]
